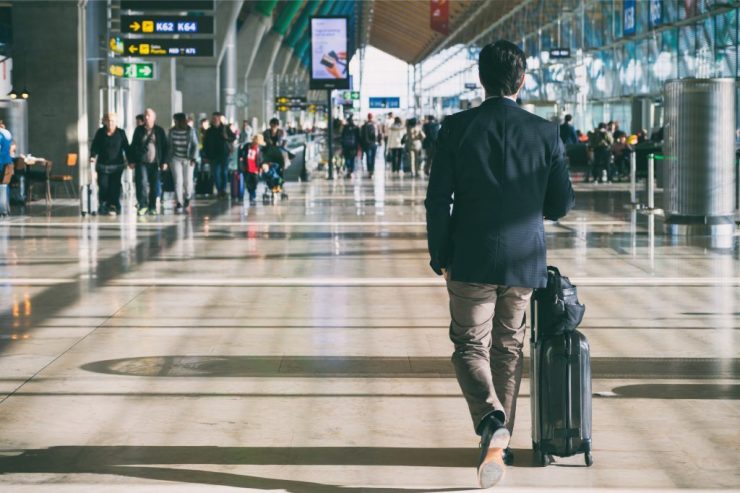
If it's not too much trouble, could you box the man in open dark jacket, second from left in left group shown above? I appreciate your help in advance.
[128,108,169,216]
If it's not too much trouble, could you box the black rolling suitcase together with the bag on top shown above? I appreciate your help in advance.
[530,267,593,466]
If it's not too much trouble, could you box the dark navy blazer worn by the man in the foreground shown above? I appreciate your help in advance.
[425,98,574,288]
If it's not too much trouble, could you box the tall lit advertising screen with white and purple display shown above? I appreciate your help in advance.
[309,17,350,90]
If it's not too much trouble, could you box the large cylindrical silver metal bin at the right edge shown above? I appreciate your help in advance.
[663,78,735,235]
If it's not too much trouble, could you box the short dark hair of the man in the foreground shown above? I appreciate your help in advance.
[478,39,527,96]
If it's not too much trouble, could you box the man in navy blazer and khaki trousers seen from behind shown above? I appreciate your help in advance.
[425,41,574,488]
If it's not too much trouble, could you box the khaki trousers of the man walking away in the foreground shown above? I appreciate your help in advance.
[447,281,532,434]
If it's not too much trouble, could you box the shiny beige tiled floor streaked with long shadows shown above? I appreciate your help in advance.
[0,160,740,493]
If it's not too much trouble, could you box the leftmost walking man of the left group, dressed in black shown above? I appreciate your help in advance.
[90,113,129,216]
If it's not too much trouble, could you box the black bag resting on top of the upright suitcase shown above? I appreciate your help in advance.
[534,265,586,337]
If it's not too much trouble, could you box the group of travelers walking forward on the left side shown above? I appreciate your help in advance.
[90,108,289,216]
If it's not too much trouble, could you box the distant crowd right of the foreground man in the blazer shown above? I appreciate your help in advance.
[560,115,663,183]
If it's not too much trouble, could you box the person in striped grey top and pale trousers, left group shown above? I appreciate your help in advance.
[167,113,198,214]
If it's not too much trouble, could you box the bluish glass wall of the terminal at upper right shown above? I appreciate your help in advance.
[422,0,740,131]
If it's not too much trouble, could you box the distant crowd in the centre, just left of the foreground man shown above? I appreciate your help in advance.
[332,112,440,178]
